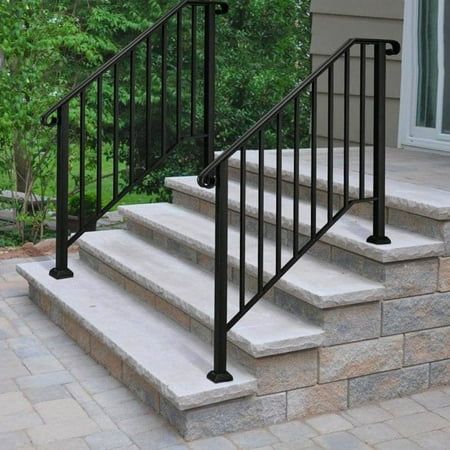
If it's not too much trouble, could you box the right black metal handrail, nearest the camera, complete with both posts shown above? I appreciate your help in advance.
[198,39,400,383]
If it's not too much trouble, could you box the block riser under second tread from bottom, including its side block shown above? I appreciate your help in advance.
[80,249,324,395]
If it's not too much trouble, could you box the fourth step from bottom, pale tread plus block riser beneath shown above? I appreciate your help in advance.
[166,177,445,298]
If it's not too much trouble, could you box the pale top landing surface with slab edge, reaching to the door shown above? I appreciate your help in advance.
[230,148,450,220]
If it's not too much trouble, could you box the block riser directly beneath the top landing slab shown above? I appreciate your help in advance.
[229,166,450,244]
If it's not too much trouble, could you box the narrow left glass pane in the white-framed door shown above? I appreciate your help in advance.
[416,0,439,128]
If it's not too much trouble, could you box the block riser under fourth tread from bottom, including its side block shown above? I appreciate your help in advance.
[173,192,438,298]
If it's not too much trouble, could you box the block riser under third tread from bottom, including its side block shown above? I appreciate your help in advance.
[127,219,386,345]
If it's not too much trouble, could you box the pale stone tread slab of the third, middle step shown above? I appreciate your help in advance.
[120,203,384,308]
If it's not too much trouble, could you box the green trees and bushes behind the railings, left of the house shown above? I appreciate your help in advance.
[0,0,310,246]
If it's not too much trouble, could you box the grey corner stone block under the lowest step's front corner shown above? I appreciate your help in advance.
[161,392,286,440]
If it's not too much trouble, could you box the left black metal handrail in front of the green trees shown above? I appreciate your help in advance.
[41,0,228,279]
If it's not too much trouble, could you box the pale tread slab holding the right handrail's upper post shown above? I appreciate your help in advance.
[166,177,445,263]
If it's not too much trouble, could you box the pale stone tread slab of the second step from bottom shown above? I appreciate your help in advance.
[79,230,323,358]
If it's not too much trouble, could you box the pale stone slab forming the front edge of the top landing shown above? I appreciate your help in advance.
[230,148,450,220]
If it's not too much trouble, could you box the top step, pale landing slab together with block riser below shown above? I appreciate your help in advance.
[230,148,450,241]
